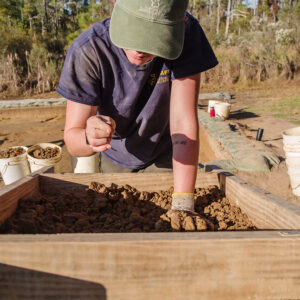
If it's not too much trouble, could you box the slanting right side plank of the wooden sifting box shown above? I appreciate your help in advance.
[219,172,300,229]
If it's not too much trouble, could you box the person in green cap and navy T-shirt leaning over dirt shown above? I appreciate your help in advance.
[57,0,218,216]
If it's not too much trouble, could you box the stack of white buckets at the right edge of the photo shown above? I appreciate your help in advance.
[282,127,300,196]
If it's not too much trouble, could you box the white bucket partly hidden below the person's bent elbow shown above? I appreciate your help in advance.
[71,153,99,173]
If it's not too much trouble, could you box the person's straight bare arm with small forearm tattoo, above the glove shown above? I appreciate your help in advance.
[170,74,200,193]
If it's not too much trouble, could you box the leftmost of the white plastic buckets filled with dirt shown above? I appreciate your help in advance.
[0,146,30,185]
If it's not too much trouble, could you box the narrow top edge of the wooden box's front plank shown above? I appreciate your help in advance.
[0,230,300,243]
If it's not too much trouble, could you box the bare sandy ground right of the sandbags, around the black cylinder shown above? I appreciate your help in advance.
[227,87,300,206]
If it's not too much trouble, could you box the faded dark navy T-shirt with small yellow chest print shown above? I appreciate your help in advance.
[57,15,218,169]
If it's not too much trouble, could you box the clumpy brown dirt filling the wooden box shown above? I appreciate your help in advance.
[0,182,255,234]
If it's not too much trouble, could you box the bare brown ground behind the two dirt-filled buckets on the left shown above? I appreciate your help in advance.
[0,105,72,177]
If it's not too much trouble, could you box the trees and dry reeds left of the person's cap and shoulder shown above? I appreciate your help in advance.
[0,0,112,93]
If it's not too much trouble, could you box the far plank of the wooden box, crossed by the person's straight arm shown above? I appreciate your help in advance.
[40,172,219,192]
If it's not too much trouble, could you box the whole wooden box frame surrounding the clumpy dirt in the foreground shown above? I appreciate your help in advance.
[0,169,300,299]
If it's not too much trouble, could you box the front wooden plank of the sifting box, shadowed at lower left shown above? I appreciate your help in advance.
[0,231,300,300]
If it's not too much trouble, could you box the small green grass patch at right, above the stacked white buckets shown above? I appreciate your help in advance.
[245,96,300,125]
